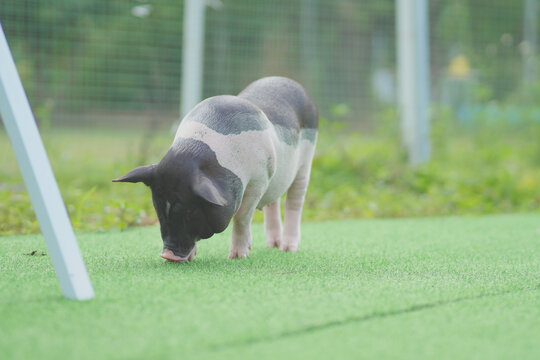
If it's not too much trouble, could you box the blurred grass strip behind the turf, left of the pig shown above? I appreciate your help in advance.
[0,129,169,235]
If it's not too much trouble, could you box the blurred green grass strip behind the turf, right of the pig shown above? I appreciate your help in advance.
[306,109,540,219]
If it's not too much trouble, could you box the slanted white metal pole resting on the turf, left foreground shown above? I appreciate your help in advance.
[0,24,94,300]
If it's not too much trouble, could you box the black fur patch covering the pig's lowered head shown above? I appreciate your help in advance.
[150,139,244,257]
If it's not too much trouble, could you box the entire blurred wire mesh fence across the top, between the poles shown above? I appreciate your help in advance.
[0,0,540,126]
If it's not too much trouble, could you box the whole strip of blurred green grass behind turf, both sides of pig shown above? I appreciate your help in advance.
[0,106,540,235]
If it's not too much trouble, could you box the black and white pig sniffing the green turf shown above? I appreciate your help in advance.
[113,77,318,262]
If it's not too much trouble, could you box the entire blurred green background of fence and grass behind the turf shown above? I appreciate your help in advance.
[0,0,540,235]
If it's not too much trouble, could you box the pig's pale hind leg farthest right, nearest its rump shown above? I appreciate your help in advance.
[280,163,311,252]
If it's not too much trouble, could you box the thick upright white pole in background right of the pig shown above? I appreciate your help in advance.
[396,0,431,165]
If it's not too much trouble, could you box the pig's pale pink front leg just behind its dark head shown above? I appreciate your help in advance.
[229,194,260,259]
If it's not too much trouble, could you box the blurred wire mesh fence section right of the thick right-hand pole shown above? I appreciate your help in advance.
[430,0,540,123]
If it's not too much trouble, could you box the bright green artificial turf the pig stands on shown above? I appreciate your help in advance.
[0,214,540,359]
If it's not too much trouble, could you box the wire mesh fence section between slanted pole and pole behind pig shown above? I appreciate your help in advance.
[0,0,182,125]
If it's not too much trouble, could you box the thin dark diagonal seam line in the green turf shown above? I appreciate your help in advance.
[208,284,540,351]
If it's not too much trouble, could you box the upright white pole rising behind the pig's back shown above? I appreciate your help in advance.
[180,0,205,118]
